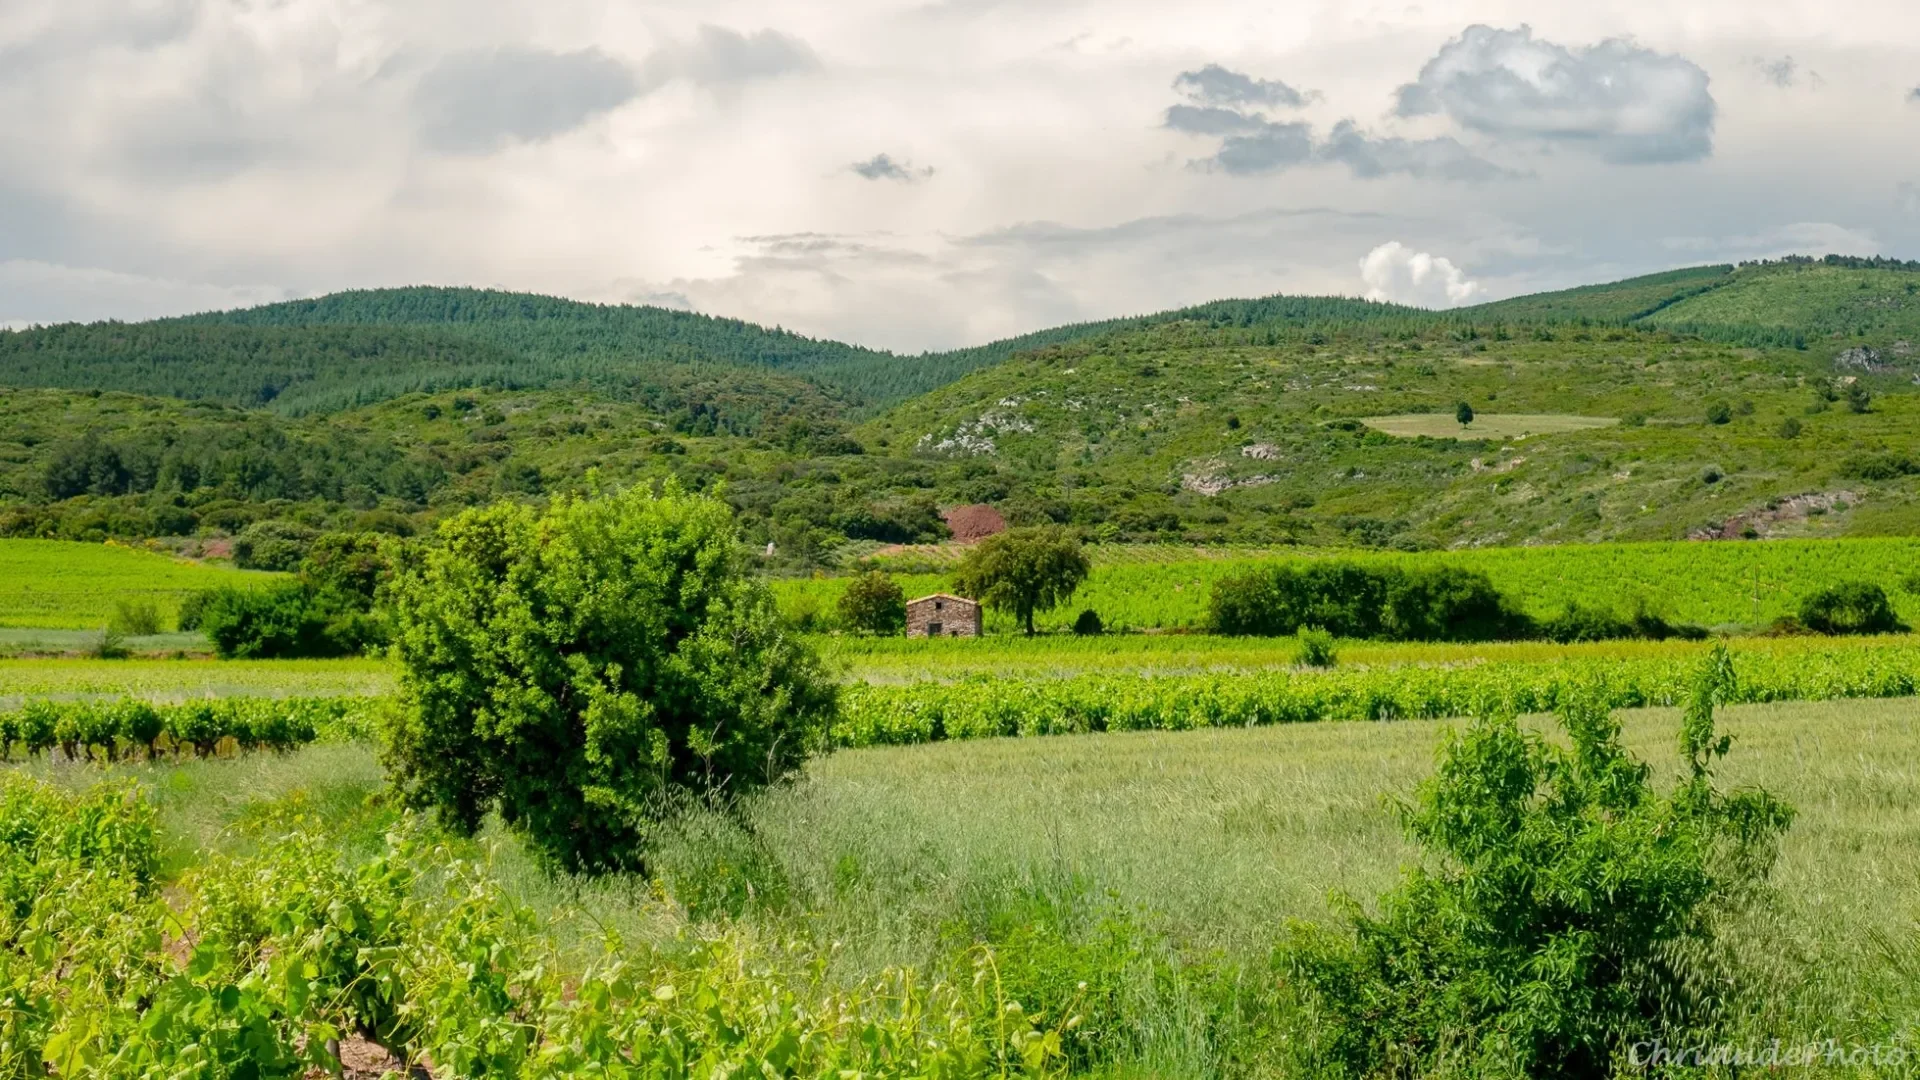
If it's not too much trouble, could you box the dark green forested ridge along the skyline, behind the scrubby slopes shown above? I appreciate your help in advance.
[11,256,1920,424]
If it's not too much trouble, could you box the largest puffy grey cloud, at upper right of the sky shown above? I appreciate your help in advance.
[1396,25,1716,165]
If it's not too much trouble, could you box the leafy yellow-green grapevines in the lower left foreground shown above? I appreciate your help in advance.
[0,776,1068,1078]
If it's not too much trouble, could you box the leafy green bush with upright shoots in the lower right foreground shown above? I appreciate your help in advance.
[1284,651,1793,1080]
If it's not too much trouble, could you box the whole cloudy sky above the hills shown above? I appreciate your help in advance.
[0,0,1920,352]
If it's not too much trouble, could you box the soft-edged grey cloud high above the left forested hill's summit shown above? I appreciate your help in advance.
[413,48,639,154]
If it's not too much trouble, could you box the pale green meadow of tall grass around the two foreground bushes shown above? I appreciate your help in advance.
[19,700,1920,1080]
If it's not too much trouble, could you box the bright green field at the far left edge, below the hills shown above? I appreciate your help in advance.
[0,540,275,630]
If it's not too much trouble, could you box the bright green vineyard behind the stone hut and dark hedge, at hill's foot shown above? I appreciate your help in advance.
[776,538,1920,634]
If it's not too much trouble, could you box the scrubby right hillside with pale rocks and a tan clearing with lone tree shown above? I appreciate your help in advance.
[856,311,1920,548]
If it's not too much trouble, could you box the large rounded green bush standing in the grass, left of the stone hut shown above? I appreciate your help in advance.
[386,488,835,871]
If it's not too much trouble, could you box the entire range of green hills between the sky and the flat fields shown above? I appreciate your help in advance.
[11,258,1920,553]
